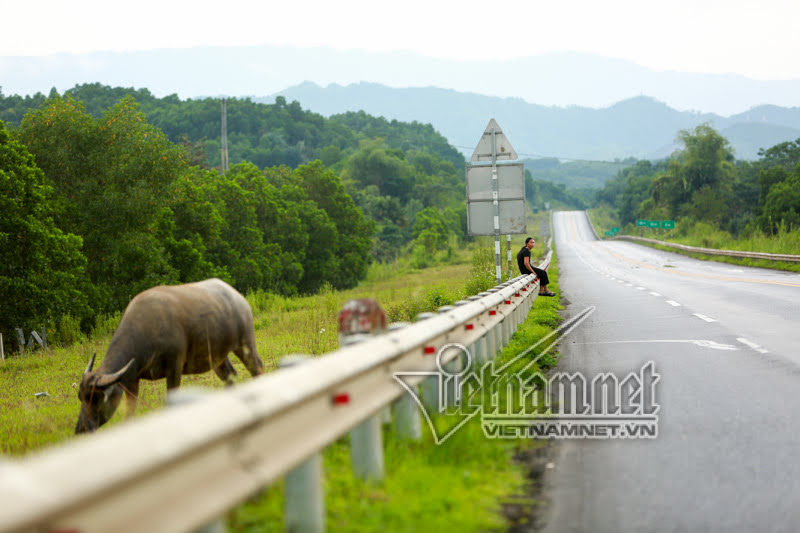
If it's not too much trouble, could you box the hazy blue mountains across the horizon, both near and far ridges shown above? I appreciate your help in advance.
[6,45,800,160]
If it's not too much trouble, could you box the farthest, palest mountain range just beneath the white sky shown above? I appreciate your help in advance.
[0,46,800,116]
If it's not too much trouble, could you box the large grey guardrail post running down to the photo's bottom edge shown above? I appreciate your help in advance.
[279,355,325,533]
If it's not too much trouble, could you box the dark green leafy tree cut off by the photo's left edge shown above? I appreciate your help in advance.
[0,122,91,338]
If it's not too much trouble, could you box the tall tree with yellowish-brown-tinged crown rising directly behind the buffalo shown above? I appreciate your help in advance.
[20,97,187,311]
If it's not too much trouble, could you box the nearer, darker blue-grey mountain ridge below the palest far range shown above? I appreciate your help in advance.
[268,82,800,161]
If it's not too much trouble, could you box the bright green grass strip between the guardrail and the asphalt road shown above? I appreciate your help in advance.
[228,261,561,533]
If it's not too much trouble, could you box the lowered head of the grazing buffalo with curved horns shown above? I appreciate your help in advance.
[75,353,133,433]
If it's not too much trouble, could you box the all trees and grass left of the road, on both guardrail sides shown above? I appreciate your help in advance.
[0,84,564,531]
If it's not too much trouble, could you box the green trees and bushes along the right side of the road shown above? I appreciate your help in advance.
[590,125,800,271]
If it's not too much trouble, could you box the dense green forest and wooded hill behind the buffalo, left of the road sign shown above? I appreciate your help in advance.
[0,84,478,340]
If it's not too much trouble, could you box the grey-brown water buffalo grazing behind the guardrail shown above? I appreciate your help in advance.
[75,279,263,433]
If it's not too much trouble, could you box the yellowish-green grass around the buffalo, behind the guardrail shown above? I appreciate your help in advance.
[0,257,478,455]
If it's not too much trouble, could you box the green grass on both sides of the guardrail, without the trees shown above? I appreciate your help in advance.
[0,218,559,532]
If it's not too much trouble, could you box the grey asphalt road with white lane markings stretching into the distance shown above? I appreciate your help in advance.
[543,212,800,532]
